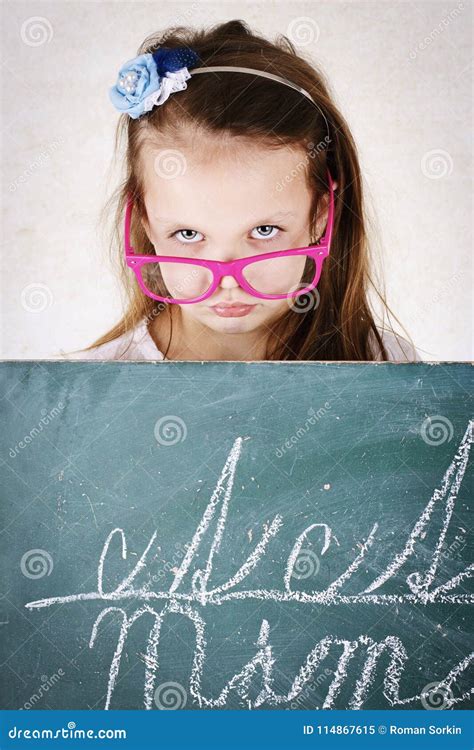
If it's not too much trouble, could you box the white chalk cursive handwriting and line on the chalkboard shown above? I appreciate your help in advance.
[25,421,474,709]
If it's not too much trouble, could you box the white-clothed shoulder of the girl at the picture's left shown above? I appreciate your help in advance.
[63,319,163,360]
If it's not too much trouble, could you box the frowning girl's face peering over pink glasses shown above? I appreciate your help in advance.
[141,137,325,342]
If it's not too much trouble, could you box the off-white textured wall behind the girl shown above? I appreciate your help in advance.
[0,0,473,360]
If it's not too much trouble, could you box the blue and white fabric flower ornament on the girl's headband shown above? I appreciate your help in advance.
[109,47,199,120]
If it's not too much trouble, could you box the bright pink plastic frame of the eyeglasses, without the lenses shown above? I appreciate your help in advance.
[124,169,334,305]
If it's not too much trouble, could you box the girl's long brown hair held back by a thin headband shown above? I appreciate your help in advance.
[70,20,414,360]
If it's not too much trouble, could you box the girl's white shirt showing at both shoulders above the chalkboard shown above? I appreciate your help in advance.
[61,318,421,362]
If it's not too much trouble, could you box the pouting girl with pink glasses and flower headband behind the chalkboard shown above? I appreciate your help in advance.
[62,20,420,361]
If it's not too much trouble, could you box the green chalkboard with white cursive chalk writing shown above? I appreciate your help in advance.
[0,361,473,710]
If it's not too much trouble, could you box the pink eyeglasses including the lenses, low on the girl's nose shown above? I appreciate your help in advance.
[125,170,334,305]
